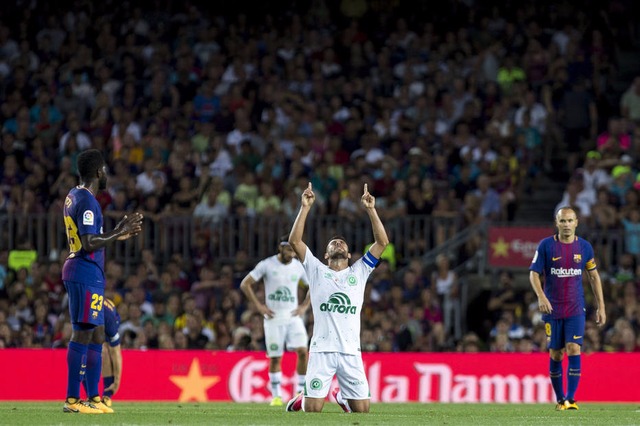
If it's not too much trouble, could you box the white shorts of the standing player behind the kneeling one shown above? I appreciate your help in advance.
[264,316,309,358]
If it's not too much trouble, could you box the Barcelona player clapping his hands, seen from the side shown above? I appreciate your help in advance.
[62,149,142,414]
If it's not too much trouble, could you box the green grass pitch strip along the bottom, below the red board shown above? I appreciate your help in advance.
[0,401,640,426]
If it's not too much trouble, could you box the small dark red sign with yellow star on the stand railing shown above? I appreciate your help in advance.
[487,226,554,268]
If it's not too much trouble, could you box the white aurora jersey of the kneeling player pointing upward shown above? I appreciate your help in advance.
[303,247,378,355]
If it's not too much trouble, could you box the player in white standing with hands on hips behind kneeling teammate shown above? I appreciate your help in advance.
[240,235,311,407]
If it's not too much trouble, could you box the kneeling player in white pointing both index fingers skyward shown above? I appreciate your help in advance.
[287,183,389,413]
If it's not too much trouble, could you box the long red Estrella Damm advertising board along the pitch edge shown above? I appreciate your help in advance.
[0,349,640,403]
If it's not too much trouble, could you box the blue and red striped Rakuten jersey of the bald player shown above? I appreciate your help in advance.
[529,235,596,320]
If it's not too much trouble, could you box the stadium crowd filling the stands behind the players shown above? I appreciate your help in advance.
[0,0,640,352]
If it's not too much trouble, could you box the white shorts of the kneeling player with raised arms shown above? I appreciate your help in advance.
[305,352,371,399]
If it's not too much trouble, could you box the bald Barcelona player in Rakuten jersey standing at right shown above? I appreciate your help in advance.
[529,207,607,410]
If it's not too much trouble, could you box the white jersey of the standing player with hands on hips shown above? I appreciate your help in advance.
[249,255,309,319]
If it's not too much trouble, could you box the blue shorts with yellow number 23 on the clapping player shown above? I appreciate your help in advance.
[64,281,104,329]
